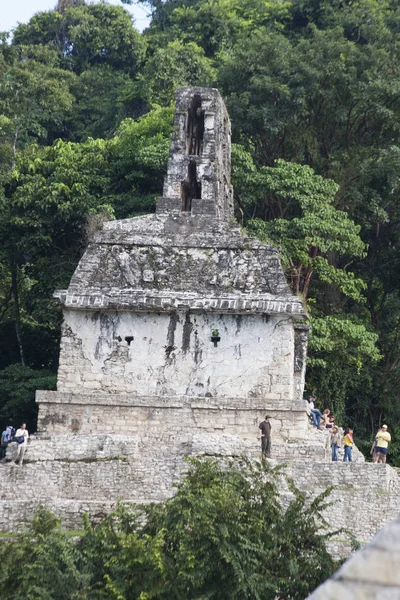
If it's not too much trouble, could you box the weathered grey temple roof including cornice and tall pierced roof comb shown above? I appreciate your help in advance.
[55,88,306,318]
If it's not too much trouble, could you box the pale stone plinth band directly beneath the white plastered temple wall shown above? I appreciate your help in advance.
[37,391,310,452]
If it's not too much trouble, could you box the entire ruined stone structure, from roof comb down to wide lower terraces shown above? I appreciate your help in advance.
[0,88,400,554]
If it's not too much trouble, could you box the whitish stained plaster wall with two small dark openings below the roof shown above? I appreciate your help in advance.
[58,310,295,408]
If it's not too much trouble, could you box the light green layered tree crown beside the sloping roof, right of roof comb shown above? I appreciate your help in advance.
[247,160,365,300]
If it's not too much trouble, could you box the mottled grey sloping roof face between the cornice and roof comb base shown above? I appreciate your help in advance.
[66,236,288,296]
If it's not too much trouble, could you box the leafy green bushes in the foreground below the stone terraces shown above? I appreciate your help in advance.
[0,459,337,600]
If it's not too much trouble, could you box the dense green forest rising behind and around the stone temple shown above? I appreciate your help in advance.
[0,0,400,464]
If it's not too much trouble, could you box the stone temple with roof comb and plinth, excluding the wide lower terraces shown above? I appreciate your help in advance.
[37,88,307,453]
